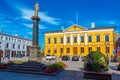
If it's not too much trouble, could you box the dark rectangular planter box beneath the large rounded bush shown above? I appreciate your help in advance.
[83,71,112,80]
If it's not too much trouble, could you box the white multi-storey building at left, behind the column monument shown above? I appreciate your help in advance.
[0,32,32,60]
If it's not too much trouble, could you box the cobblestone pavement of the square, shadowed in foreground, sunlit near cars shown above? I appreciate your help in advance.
[0,61,120,80]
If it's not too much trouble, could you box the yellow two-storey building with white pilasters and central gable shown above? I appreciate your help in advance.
[44,25,115,56]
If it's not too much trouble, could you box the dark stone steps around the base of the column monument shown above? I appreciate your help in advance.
[6,62,47,73]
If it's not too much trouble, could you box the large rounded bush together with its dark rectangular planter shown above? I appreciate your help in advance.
[83,51,112,80]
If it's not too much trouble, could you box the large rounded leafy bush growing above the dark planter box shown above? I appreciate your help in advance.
[83,51,109,72]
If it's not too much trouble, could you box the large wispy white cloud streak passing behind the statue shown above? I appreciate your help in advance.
[6,0,61,25]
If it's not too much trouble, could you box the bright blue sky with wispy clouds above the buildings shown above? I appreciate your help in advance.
[0,0,120,48]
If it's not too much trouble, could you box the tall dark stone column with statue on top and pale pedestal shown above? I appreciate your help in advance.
[28,2,40,62]
